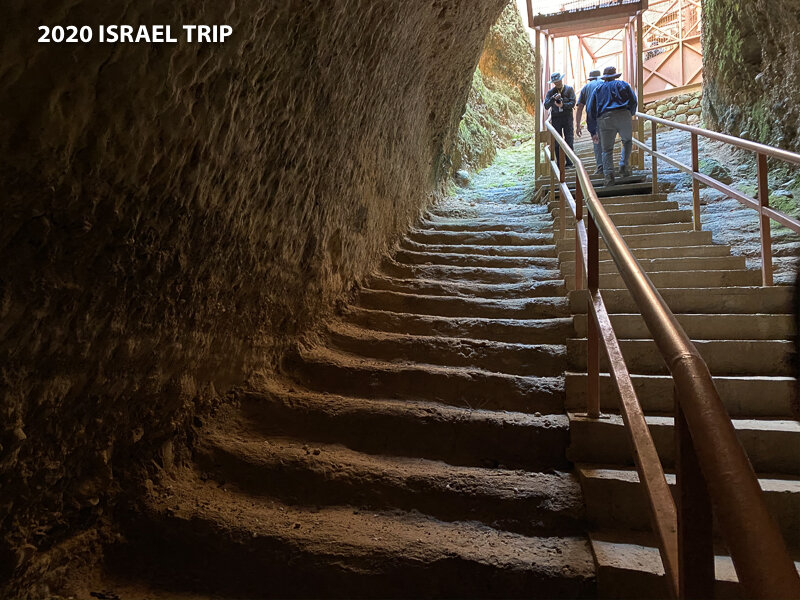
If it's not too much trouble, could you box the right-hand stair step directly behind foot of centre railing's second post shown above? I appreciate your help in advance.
[566,371,797,419]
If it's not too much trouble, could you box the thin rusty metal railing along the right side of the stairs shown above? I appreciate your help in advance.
[633,112,800,285]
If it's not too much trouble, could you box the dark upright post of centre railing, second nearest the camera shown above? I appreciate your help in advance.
[575,212,600,419]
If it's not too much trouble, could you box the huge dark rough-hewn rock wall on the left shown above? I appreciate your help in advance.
[0,0,505,596]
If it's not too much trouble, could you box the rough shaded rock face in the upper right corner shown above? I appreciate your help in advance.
[703,0,800,150]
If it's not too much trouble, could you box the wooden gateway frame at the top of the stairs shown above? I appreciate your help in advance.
[527,0,648,180]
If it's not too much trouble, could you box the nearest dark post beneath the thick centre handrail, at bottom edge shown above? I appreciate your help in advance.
[675,390,715,600]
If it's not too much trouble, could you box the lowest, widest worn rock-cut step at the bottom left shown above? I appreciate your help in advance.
[119,471,594,598]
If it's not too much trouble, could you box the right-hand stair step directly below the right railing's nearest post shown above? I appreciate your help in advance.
[569,286,794,314]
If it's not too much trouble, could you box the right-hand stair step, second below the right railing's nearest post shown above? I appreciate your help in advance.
[575,313,795,340]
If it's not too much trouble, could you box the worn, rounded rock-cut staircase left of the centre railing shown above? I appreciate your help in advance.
[104,195,595,598]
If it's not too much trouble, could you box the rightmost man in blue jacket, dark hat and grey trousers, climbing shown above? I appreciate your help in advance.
[586,67,638,185]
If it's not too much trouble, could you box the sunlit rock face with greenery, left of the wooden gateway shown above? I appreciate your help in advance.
[451,2,536,170]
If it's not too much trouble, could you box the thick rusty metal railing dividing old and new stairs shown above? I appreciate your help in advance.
[545,119,800,599]
